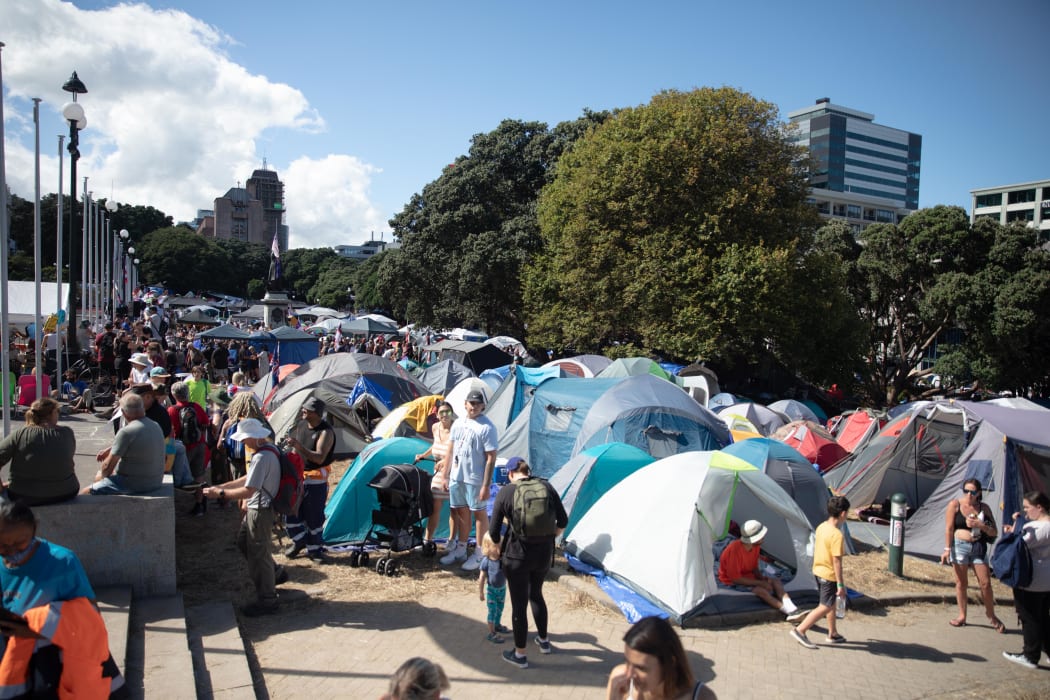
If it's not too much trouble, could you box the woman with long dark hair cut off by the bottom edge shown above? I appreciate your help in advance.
[606,617,715,700]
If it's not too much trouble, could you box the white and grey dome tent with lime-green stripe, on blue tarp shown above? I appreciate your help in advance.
[565,452,816,622]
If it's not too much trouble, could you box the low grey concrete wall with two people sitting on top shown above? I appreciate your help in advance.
[33,475,175,597]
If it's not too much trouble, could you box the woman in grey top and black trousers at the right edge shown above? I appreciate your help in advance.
[1003,491,1050,670]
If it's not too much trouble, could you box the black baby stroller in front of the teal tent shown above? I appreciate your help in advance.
[350,464,438,576]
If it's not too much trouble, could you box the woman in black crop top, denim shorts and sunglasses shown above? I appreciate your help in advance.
[941,479,1006,634]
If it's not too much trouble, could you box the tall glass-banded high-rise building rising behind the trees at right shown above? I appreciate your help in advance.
[788,98,922,232]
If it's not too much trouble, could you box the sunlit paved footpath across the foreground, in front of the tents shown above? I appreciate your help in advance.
[244,578,1050,700]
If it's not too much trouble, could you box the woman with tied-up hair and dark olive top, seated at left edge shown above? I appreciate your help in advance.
[0,398,80,506]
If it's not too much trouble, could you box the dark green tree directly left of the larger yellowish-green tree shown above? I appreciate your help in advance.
[384,111,608,337]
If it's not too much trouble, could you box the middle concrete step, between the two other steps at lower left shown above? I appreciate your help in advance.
[125,594,197,700]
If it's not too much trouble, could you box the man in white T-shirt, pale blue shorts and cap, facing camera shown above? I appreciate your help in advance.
[441,389,499,571]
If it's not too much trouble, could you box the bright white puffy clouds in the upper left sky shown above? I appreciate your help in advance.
[0,0,386,246]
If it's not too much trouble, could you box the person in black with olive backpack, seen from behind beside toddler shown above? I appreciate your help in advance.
[488,457,569,669]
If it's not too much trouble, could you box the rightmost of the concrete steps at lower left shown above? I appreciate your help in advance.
[186,602,258,700]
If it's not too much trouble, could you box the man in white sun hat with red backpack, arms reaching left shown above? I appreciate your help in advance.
[204,418,280,617]
